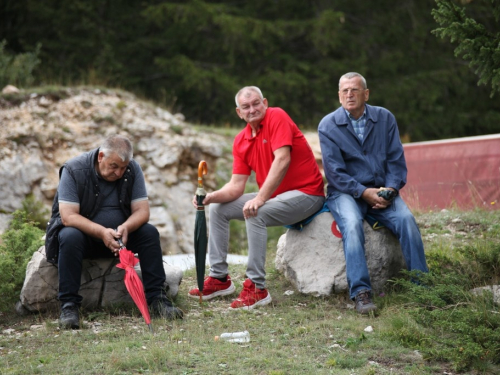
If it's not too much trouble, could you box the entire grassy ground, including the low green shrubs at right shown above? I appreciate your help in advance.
[0,211,500,375]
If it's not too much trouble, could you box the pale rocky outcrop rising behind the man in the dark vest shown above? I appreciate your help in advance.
[0,88,230,255]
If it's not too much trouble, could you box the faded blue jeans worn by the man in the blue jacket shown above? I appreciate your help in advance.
[327,193,429,299]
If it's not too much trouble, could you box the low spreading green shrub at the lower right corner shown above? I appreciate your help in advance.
[389,270,500,372]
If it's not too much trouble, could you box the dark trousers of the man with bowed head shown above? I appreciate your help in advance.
[58,223,165,305]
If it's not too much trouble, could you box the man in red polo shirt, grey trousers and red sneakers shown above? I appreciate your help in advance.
[189,86,324,310]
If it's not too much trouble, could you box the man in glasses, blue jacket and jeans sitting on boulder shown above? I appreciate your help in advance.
[318,73,428,314]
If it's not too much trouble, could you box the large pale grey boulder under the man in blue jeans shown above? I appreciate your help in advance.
[275,212,406,296]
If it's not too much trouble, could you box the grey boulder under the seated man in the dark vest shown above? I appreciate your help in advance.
[16,246,183,314]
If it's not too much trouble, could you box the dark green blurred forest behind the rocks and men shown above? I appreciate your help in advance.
[0,0,500,141]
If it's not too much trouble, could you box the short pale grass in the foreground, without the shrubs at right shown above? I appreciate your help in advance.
[0,266,427,374]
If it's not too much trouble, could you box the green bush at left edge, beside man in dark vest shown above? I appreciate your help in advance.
[0,210,44,311]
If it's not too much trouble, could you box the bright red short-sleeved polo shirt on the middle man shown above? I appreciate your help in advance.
[233,107,324,198]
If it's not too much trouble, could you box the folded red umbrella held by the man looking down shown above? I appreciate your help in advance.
[116,239,153,332]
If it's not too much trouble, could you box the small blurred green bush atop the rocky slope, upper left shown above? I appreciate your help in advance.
[0,40,42,87]
